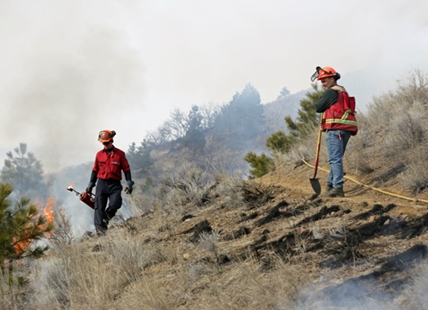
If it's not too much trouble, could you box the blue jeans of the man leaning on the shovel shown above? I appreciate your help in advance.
[326,130,351,188]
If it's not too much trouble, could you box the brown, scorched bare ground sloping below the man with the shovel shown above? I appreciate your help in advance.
[72,166,428,309]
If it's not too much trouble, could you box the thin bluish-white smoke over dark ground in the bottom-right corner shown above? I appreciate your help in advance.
[296,244,428,310]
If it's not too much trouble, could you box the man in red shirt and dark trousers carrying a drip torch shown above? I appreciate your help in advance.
[86,130,134,234]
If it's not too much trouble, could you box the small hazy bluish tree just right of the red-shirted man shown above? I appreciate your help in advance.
[126,140,154,177]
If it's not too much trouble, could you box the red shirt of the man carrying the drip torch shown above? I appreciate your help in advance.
[92,146,131,180]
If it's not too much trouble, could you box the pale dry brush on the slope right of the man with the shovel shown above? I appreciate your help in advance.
[346,71,428,186]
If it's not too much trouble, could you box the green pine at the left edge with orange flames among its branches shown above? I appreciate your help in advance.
[0,182,53,268]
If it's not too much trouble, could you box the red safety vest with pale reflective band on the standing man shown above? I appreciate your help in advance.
[321,85,358,136]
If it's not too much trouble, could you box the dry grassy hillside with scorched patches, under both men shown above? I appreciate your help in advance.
[0,72,428,310]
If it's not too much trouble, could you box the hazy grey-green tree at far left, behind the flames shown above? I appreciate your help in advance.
[1,143,46,197]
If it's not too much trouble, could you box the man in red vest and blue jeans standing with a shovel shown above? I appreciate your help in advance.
[311,67,358,197]
